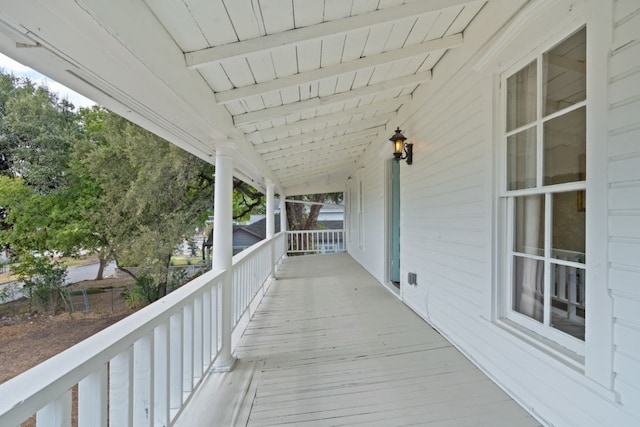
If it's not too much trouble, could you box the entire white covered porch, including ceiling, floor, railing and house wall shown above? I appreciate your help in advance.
[0,0,640,427]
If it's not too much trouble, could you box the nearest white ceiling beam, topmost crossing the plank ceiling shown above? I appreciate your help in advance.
[184,0,470,69]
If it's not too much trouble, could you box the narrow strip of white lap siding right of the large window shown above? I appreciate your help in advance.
[608,0,640,418]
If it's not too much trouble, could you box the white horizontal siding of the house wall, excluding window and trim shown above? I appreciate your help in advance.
[344,0,640,426]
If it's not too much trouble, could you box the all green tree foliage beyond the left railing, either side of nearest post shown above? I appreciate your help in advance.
[0,73,264,310]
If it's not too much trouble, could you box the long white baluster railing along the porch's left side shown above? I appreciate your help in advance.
[0,233,286,427]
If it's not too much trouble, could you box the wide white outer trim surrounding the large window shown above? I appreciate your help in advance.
[490,0,616,394]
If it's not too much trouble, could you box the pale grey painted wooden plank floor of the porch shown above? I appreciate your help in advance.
[177,254,539,427]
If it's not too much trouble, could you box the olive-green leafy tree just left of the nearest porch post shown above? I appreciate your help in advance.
[77,110,213,296]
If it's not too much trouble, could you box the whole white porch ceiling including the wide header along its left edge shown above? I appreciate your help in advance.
[0,0,485,194]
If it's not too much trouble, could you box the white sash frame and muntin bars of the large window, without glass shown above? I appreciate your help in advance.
[497,22,593,358]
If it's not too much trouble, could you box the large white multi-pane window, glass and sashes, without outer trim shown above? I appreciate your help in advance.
[501,28,588,354]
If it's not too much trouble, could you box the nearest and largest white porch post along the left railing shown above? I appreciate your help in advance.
[212,147,235,372]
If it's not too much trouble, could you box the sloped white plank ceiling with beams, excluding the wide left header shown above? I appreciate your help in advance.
[145,0,485,189]
